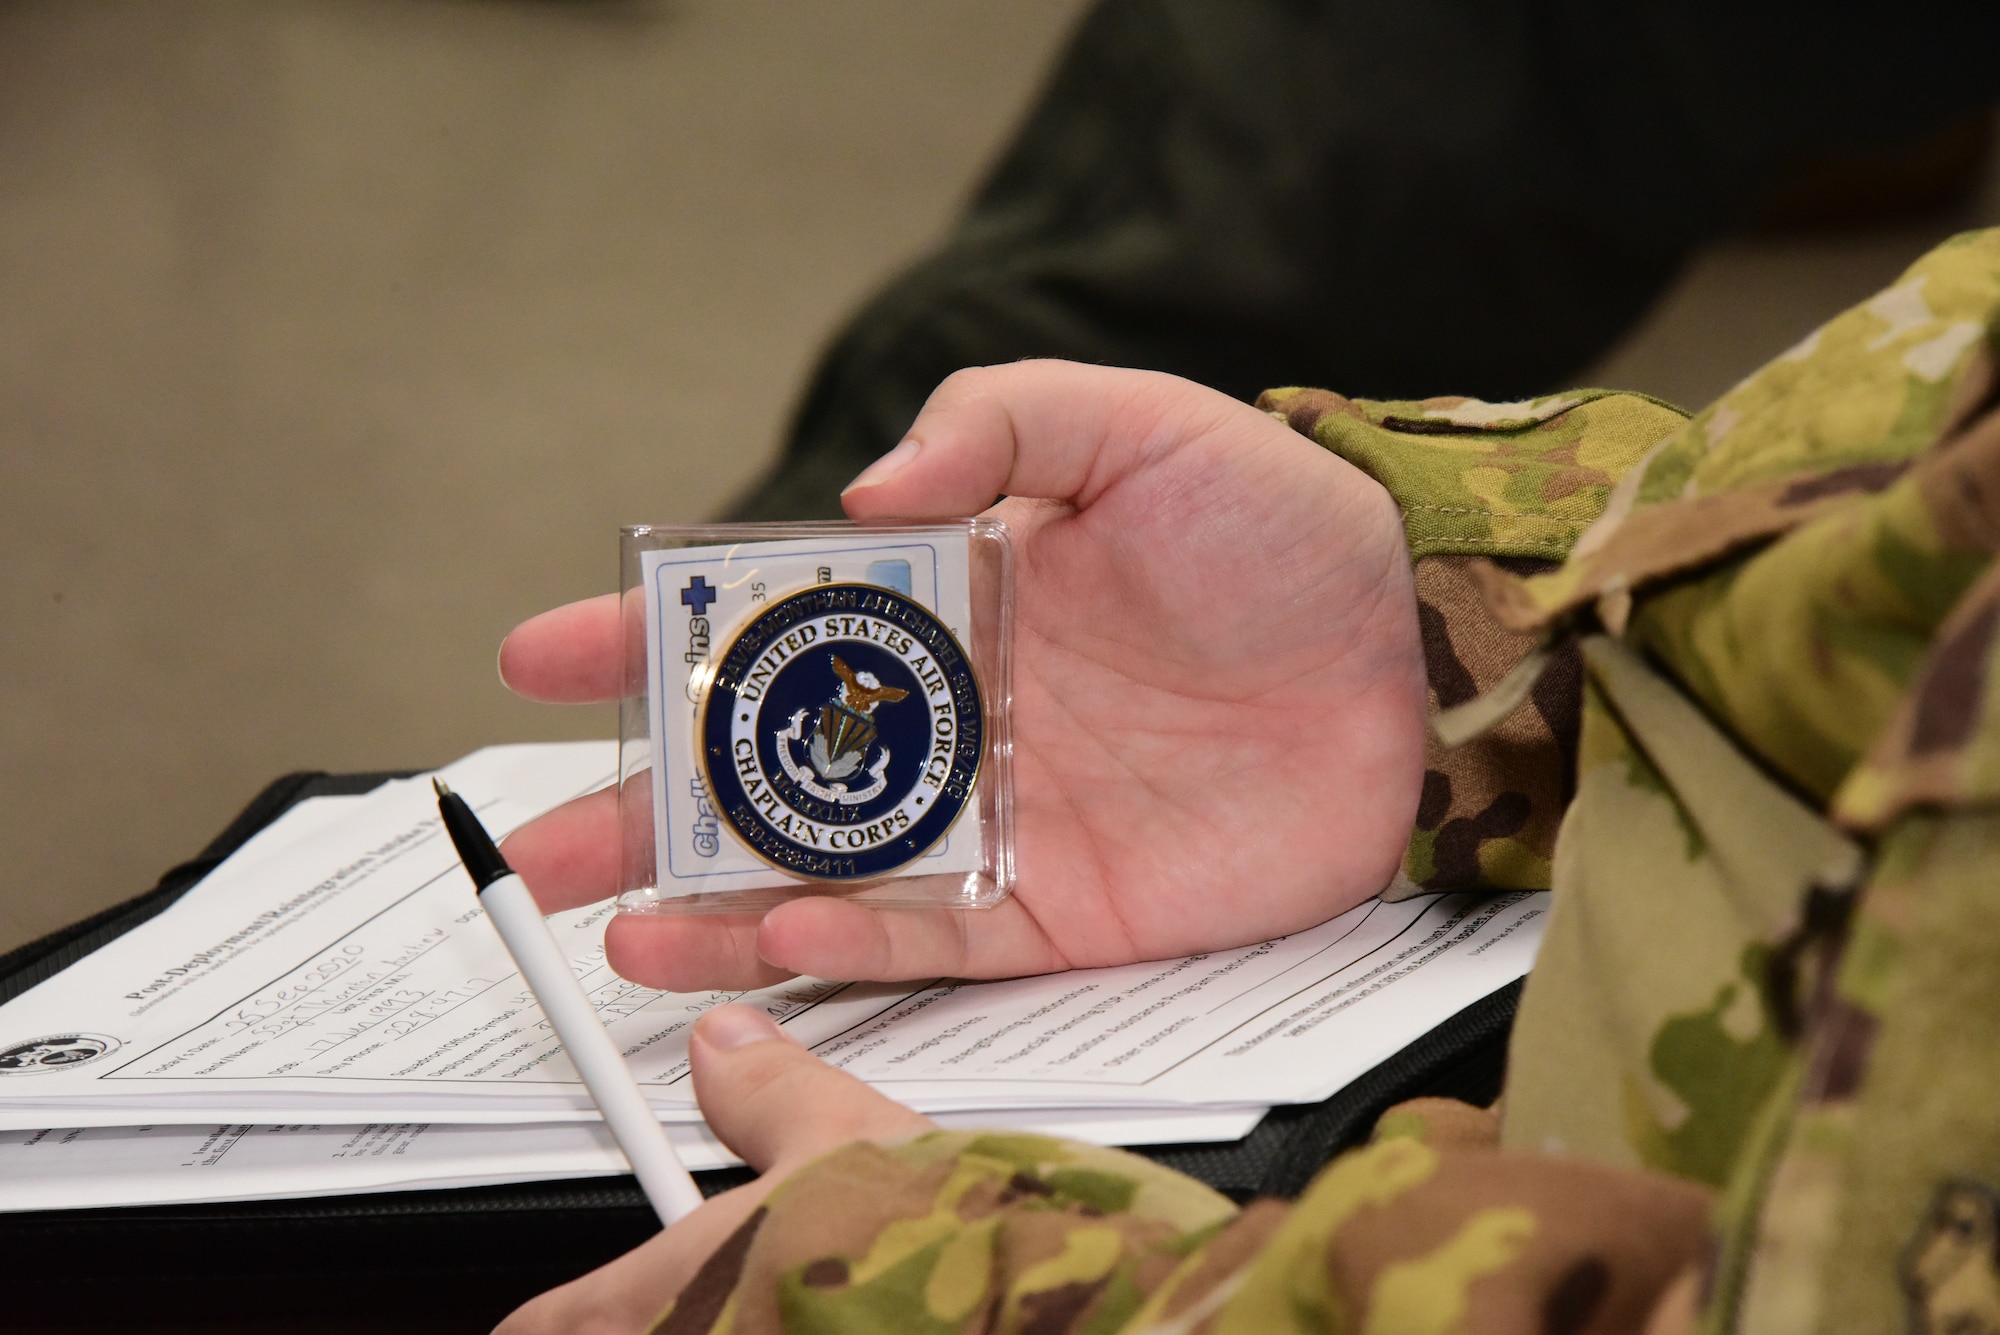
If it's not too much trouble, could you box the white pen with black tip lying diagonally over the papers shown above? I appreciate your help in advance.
[430,779,702,1223]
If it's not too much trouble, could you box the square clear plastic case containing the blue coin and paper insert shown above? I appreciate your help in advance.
[618,520,1014,913]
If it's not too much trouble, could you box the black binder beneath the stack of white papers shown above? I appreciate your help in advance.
[0,771,1520,1335]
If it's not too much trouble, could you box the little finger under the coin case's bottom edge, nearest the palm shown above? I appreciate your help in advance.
[756,897,1070,981]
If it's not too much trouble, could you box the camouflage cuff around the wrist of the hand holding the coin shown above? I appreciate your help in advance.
[1258,390,1686,897]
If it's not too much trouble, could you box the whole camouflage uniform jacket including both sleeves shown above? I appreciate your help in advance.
[658,232,2000,1335]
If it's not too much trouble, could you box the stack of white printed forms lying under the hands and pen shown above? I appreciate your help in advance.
[0,741,1546,1209]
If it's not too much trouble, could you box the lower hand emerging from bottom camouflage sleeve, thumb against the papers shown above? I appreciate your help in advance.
[494,1005,932,1335]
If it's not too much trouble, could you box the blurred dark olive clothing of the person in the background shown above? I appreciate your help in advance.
[734,0,2000,520]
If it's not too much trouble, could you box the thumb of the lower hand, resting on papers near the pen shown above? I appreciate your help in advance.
[688,1005,932,1173]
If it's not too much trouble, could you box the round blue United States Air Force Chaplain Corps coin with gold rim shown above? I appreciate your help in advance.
[696,584,986,881]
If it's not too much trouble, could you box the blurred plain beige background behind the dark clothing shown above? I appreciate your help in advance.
[0,0,2000,949]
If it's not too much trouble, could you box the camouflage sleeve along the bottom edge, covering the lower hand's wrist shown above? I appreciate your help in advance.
[654,1099,1710,1335]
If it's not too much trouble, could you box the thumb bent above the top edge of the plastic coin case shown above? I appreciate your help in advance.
[840,362,1248,520]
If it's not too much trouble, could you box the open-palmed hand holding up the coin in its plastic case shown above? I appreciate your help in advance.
[500,362,1424,991]
